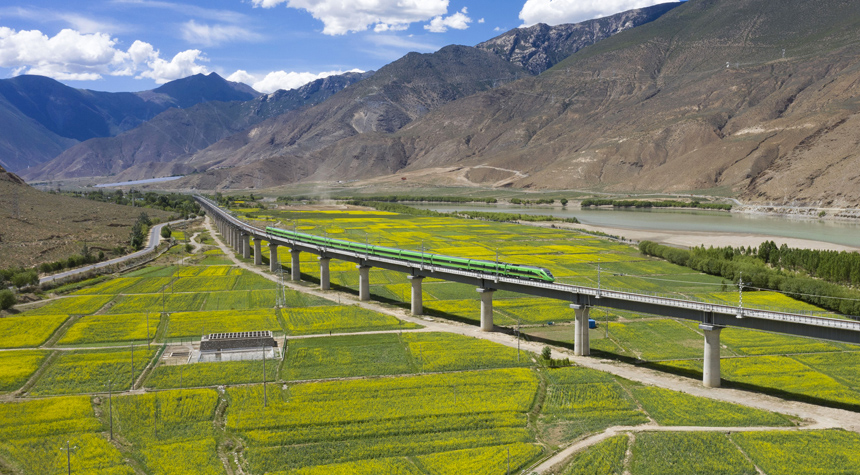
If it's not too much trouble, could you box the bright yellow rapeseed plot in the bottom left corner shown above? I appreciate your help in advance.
[0,396,134,475]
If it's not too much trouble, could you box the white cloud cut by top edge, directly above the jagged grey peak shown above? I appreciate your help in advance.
[520,0,680,26]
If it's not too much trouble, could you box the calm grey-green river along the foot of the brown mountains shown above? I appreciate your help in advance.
[409,203,860,247]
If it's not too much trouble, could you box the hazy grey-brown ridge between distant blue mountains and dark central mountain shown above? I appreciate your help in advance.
[23,73,372,181]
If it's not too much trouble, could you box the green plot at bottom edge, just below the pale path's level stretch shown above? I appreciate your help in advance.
[630,432,756,475]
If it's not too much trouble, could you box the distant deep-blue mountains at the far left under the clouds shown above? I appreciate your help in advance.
[0,73,259,171]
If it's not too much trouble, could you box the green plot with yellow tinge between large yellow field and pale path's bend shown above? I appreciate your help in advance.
[540,367,648,442]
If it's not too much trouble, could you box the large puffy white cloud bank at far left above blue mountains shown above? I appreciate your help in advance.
[0,27,208,84]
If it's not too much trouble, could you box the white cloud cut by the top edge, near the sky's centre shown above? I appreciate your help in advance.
[252,0,448,35]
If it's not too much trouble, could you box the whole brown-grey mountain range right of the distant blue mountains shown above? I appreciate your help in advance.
[10,0,860,206]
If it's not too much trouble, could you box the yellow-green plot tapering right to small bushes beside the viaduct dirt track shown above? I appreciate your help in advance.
[402,332,533,371]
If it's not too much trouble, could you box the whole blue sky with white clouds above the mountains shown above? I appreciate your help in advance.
[0,0,670,92]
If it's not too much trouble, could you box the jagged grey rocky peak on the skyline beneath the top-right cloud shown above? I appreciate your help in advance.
[476,2,680,74]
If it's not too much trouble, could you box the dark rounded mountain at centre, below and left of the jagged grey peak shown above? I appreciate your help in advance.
[176,46,525,189]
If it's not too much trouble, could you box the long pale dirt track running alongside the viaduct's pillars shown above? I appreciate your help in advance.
[204,216,860,432]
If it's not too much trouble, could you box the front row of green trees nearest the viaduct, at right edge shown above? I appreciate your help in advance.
[639,241,860,315]
